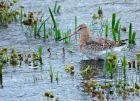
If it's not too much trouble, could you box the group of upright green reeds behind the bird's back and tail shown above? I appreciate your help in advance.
[92,7,136,45]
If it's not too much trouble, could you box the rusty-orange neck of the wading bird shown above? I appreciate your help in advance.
[80,28,91,45]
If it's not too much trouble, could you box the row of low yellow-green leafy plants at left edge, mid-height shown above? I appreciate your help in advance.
[0,46,43,66]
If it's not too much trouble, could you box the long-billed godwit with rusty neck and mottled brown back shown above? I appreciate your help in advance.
[60,24,127,59]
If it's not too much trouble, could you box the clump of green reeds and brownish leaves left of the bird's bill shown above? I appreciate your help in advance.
[20,1,69,43]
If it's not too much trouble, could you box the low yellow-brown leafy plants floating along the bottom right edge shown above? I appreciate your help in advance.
[83,79,140,101]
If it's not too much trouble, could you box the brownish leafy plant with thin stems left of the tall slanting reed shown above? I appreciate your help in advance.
[22,12,50,39]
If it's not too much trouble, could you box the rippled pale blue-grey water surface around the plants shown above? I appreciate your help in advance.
[0,0,140,101]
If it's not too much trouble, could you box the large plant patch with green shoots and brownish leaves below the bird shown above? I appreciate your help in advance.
[81,53,140,101]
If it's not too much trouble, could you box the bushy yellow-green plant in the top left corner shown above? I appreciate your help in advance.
[0,0,19,25]
